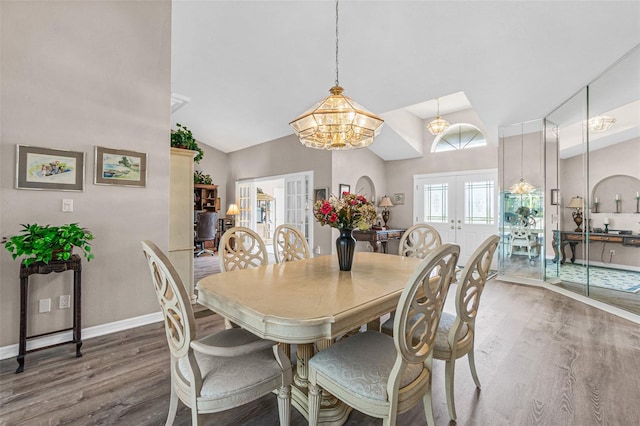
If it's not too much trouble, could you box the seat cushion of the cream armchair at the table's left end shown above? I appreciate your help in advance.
[178,336,282,401]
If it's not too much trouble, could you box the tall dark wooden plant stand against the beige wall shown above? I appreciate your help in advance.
[16,254,82,374]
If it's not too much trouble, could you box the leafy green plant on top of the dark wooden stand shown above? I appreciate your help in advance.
[4,223,94,266]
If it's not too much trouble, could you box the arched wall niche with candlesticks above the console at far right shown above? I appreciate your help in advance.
[591,175,640,213]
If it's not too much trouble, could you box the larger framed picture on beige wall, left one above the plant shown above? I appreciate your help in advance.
[16,145,84,191]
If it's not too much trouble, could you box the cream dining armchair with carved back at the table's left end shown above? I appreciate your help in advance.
[142,241,292,425]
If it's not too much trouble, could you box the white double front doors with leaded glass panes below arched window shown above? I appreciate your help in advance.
[413,169,498,265]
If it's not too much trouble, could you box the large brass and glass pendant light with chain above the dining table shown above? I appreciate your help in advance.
[289,0,384,150]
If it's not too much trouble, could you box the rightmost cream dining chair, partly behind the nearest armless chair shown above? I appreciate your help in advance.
[433,235,500,420]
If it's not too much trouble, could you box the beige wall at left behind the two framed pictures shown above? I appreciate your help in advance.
[0,1,171,346]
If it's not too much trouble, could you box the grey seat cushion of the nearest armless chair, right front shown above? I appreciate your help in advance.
[309,331,423,401]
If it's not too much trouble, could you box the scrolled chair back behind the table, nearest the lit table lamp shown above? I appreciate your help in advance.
[218,226,269,272]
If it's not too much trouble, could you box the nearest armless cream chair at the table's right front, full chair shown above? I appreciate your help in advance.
[309,244,460,425]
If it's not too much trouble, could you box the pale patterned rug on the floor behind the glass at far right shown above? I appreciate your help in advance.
[547,260,640,293]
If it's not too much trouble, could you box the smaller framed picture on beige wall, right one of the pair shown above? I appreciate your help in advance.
[93,146,147,187]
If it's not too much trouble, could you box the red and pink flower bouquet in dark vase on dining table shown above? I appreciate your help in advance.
[313,192,376,271]
